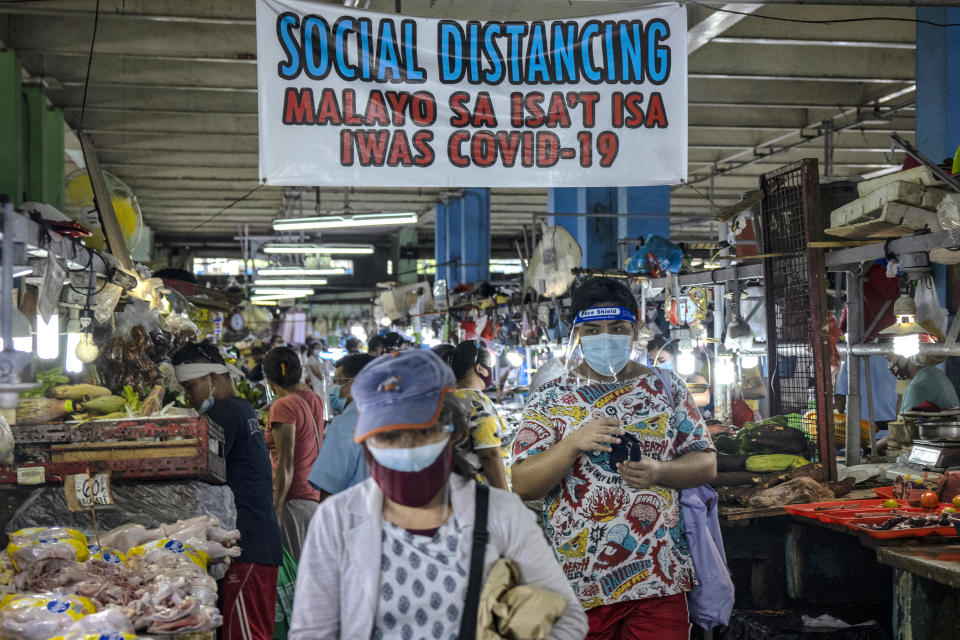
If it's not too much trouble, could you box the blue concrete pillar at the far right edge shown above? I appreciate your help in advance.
[916,7,960,309]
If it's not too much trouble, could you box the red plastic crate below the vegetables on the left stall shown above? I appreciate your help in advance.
[0,417,227,484]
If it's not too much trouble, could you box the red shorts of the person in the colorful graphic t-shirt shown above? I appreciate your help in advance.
[587,593,690,640]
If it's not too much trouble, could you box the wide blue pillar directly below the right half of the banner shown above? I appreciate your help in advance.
[547,187,670,269]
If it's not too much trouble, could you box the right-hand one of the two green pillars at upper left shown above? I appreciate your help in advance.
[23,87,63,206]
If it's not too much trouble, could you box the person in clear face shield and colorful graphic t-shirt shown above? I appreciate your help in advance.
[513,278,716,640]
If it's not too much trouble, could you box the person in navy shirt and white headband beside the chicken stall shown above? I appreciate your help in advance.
[173,342,281,640]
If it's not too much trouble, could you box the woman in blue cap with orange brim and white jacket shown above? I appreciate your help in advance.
[288,351,587,640]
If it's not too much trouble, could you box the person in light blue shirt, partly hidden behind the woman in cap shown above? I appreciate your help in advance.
[307,353,376,495]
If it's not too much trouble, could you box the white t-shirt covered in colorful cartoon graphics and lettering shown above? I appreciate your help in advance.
[513,372,713,609]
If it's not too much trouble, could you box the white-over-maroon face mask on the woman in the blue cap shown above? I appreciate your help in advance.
[365,436,453,507]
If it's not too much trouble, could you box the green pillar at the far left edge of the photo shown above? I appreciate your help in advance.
[0,49,25,204]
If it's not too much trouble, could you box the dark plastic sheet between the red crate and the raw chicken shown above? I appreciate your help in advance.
[4,480,237,535]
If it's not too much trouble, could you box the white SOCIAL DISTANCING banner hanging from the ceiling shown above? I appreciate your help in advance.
[257,0,687,187]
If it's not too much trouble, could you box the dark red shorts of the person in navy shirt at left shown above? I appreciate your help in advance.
[220,562,279,640]
